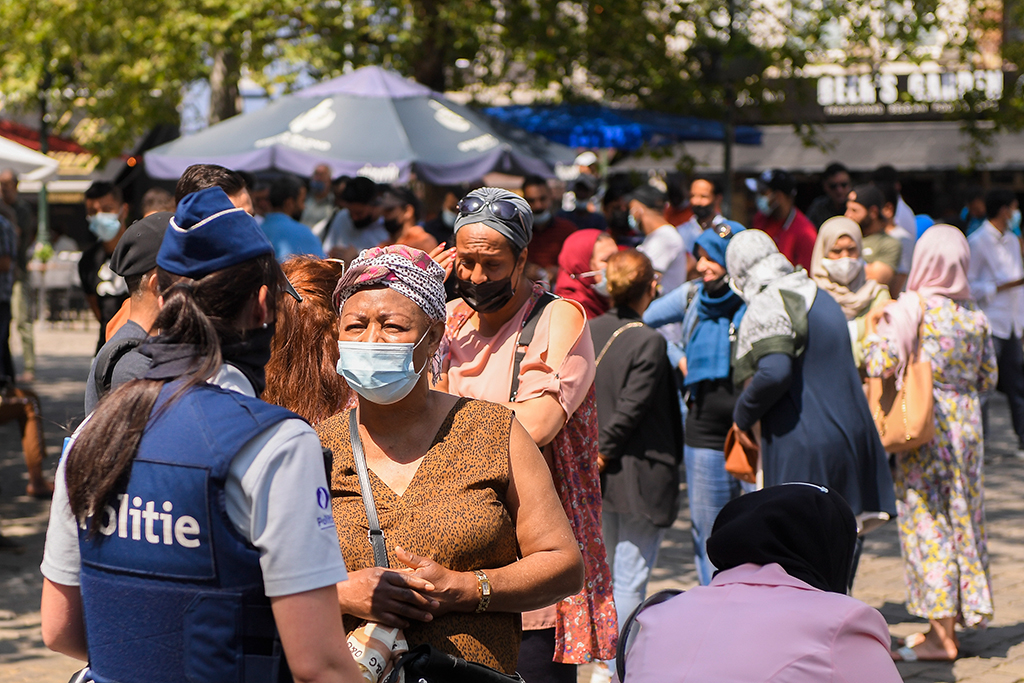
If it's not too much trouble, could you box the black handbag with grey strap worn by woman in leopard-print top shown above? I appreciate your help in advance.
[348,410,525,683]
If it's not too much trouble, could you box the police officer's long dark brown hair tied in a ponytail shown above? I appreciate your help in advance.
[66,255,283,535]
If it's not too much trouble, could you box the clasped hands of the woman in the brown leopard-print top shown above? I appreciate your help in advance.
[338,567,440,629]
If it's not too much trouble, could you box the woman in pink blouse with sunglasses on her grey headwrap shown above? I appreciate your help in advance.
[442,187,617,683]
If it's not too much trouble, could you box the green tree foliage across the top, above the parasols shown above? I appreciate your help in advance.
[0,0,1007,161]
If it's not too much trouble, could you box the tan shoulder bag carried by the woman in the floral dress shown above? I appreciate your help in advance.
[867,303,935,453]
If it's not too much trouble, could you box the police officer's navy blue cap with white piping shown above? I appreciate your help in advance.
[157,187,302,301]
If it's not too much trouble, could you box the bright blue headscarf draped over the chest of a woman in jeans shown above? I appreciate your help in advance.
[685,220,746,387]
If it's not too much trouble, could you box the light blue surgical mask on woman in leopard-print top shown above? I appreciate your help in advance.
[337,333,427,405]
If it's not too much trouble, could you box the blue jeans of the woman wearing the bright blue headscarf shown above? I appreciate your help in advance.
[683,445,756,586]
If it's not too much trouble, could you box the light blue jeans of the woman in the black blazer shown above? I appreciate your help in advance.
[601,512,668,631]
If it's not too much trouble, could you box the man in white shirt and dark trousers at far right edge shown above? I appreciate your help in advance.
[967,189,1024,457]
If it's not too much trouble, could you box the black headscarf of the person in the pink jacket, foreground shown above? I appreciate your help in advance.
[708,483,857,594]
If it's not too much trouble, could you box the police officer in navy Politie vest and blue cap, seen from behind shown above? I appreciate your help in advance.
[42,187,359,683]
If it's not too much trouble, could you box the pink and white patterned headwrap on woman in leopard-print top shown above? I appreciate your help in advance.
[334,245,447,323]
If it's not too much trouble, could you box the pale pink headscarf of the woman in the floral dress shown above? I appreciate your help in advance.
[879,224,971,385]
